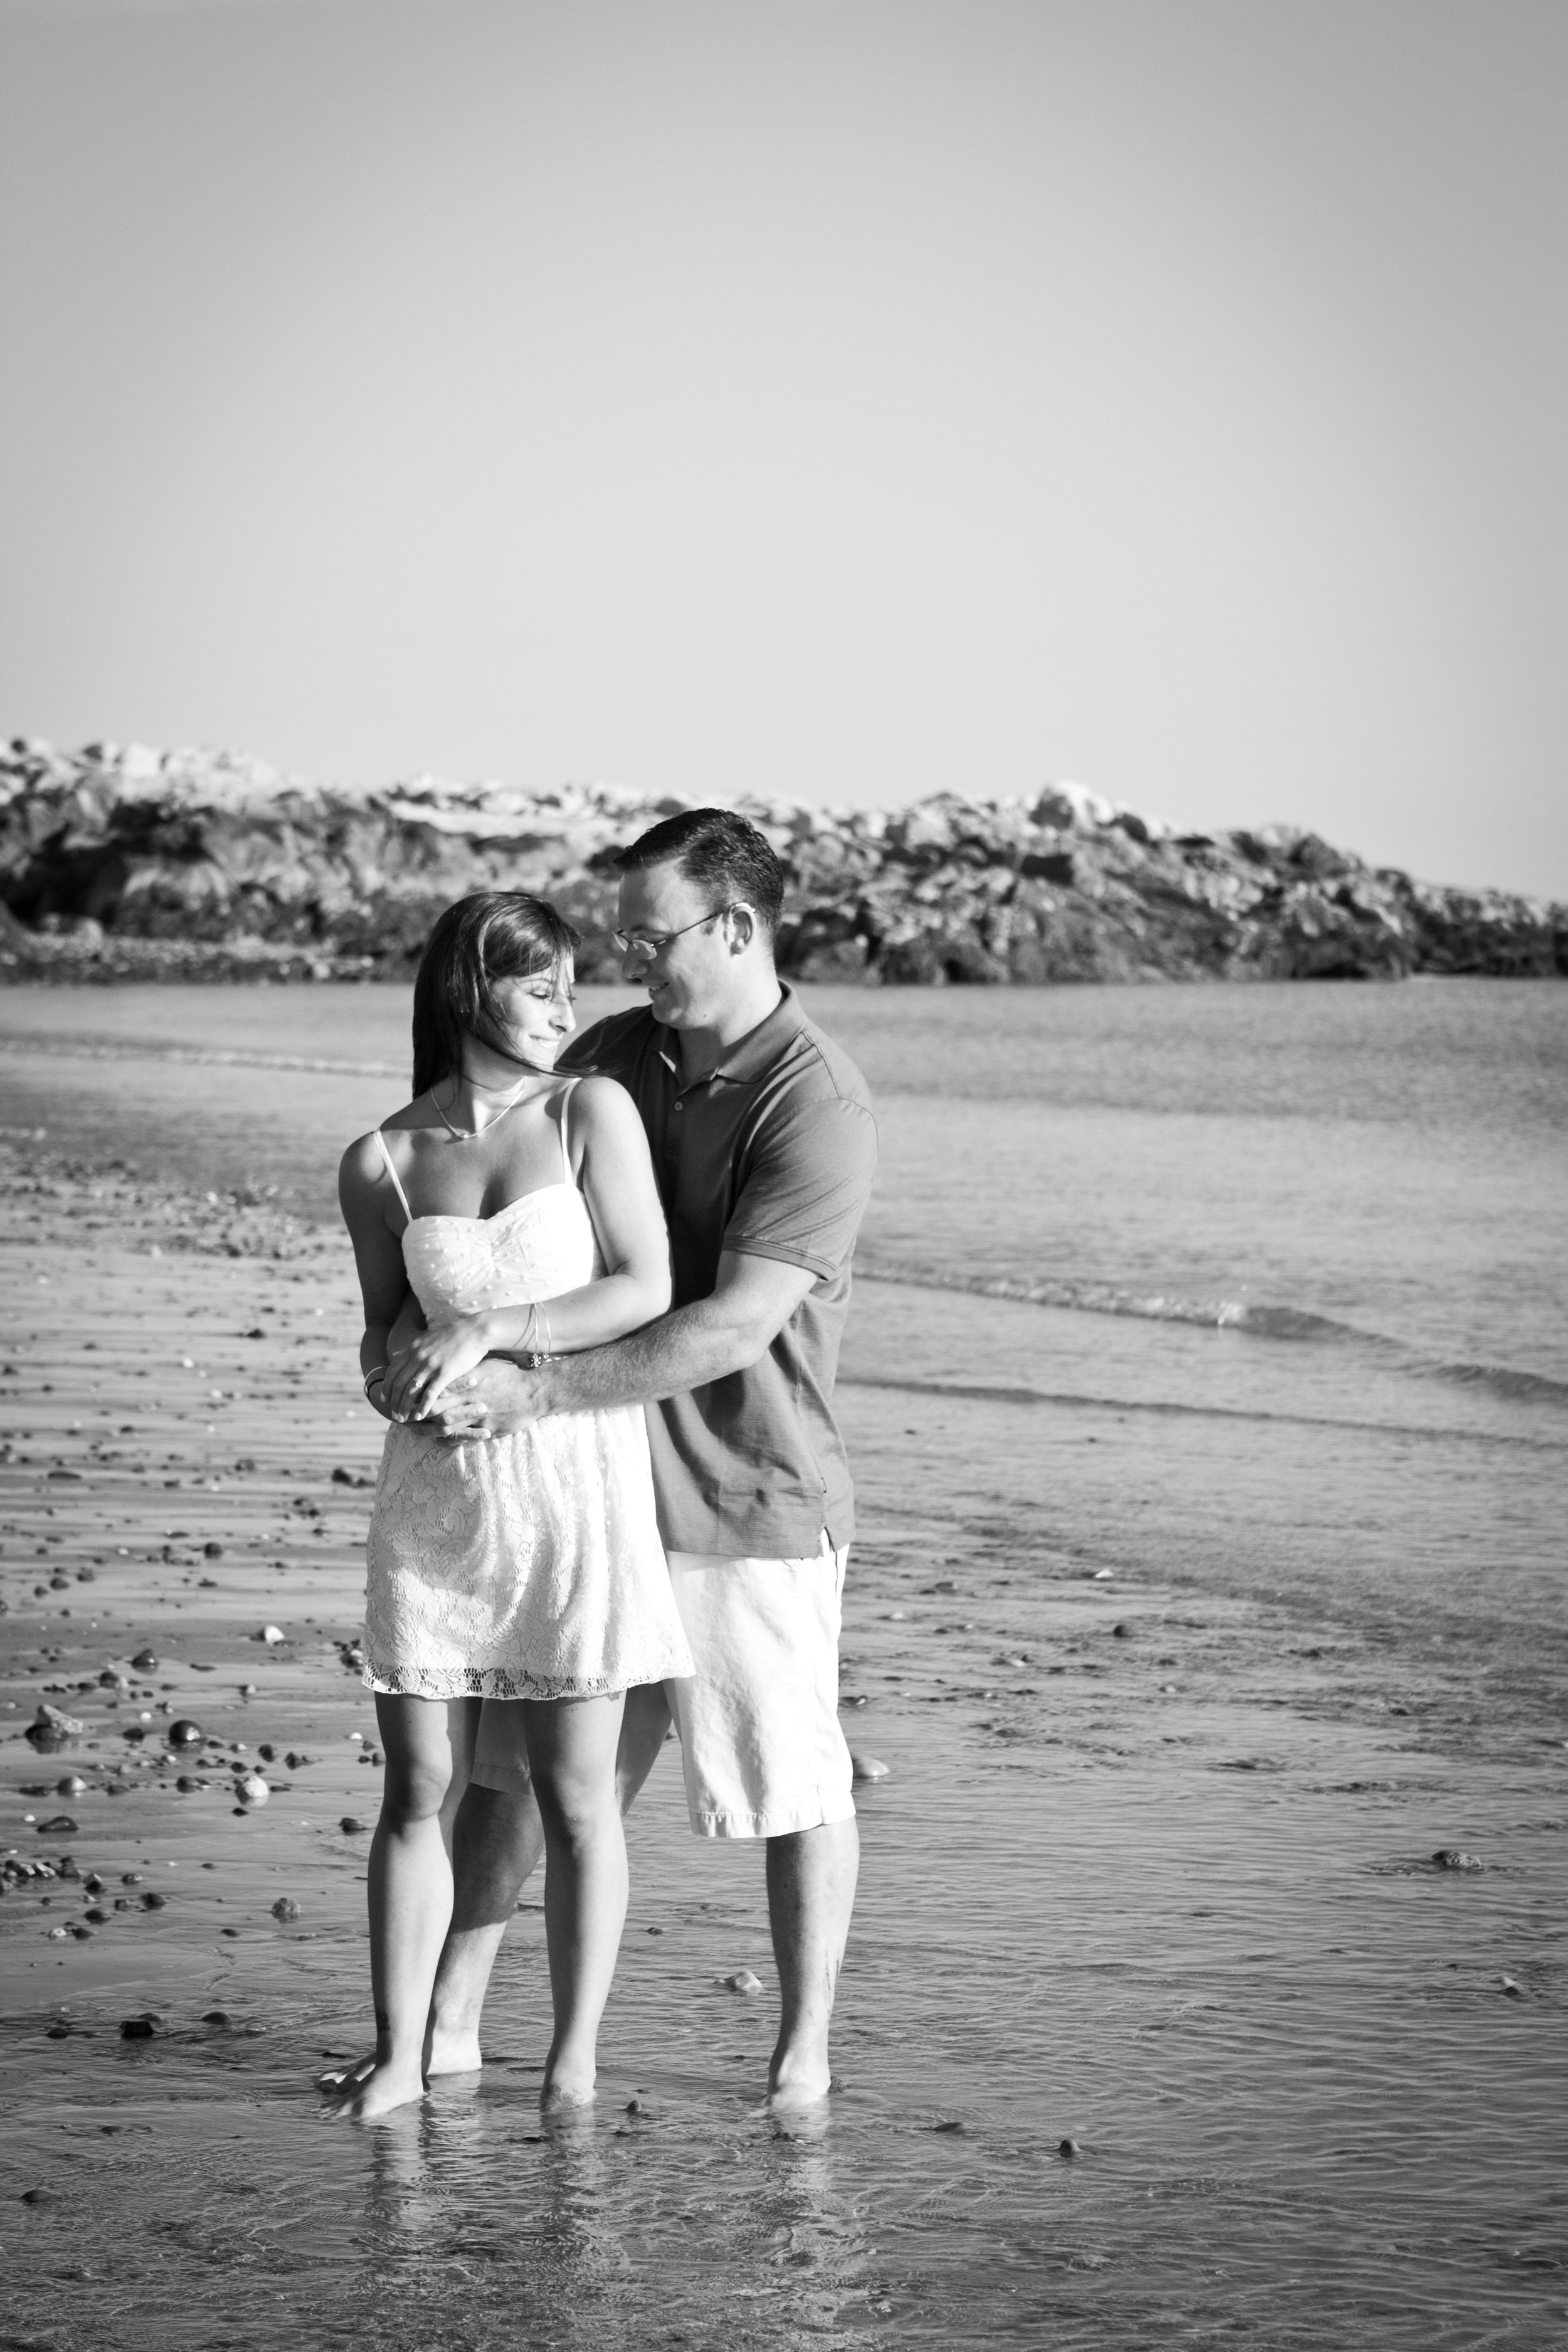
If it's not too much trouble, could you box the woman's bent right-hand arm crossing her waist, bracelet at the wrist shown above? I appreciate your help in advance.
[388,1078,670,1418]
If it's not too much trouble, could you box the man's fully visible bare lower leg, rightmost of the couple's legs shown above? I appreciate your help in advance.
[769,1818,861,2107]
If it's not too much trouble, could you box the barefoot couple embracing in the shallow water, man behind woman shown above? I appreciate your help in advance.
[324,809,877,2122]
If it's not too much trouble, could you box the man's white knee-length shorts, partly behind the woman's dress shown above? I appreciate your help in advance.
[472,1536,856,1837]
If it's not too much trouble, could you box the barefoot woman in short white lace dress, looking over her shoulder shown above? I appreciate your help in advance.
[339,891,691,2119]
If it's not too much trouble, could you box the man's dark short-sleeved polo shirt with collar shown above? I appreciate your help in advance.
[559,988,877,1559]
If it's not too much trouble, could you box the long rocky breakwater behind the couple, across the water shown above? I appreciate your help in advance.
[0,741,1568,983]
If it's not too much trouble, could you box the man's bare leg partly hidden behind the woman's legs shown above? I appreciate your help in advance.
[320,1682,670,2091]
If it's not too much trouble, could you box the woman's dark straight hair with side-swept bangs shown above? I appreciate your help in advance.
[414,889,581,1094]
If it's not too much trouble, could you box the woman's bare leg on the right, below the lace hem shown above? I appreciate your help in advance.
[524,1691,625,2110]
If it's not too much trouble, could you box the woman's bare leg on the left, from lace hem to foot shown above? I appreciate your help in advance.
[334,1691,480,2124]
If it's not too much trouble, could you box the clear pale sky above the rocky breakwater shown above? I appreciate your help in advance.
[0,0,1568,899]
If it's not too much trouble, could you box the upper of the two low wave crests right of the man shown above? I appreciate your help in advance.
[856,1256,1568,1407]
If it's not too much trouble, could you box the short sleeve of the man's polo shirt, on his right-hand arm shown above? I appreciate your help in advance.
[722,1096,877,1279]
